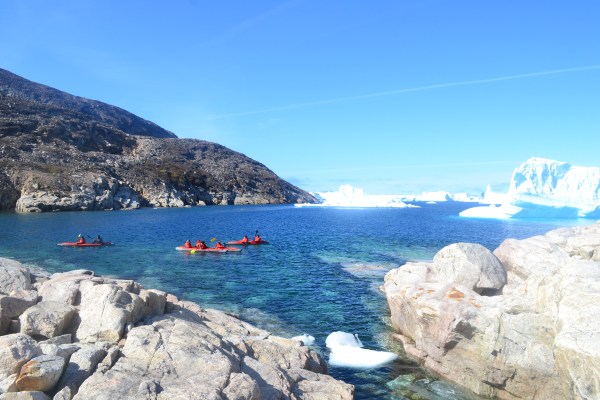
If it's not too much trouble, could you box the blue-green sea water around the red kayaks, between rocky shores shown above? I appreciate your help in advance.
[0,203,592,399]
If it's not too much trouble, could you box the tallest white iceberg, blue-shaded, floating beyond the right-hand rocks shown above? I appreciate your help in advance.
[460,157,600,218]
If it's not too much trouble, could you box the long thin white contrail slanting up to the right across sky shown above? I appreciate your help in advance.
[206,65,600,120]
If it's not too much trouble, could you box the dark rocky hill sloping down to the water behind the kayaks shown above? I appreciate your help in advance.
[0,69,315,212]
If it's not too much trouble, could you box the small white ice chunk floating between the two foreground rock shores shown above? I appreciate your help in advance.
[325,331,398,369]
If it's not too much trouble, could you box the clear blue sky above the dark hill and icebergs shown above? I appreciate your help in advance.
[0,0,600,194]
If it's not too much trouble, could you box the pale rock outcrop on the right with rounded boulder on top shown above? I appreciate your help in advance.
[384,222,600,400]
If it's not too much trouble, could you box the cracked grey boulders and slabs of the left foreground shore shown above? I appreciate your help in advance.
[0,258,354,400]
